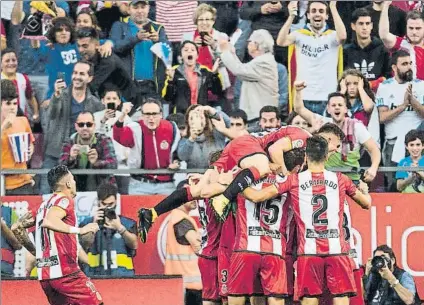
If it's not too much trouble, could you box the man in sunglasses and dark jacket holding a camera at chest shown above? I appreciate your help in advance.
[59,111,118,192]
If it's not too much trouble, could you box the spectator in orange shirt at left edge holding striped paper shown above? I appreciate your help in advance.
[1,79,35,196]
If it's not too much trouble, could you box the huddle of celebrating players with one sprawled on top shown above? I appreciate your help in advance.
[139,86,371,305]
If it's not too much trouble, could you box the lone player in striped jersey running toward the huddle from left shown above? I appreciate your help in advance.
[35,165,103,305]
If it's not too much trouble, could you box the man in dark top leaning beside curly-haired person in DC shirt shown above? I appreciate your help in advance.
[77,28,141,109]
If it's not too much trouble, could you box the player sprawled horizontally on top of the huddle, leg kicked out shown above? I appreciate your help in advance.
[138,124,344,243]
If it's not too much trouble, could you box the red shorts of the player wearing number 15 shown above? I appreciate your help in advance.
[228,252,287,298]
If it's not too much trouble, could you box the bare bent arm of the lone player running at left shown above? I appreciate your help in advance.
[41,206,99,234]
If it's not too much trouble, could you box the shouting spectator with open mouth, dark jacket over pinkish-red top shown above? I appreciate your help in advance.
[162,41,223,113]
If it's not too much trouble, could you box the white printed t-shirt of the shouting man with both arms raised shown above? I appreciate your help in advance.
[292,31,339,101]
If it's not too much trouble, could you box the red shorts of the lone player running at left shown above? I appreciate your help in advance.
[40,271,103,305]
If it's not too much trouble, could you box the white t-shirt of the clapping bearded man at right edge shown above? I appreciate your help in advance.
[376,78,424,139]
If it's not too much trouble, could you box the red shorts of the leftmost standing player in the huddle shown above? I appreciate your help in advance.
[198,256,221,303]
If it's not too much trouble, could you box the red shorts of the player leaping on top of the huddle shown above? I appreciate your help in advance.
[213,135,266,172]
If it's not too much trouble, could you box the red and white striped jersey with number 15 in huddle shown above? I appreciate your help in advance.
[234,175,288,256]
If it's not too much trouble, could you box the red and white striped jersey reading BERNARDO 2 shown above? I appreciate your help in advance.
[279,170,356,256]
